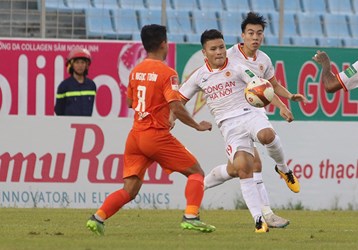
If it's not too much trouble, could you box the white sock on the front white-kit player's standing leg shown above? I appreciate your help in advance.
[240,178,262,222]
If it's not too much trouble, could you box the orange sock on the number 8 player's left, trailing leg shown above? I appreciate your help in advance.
[96,189,131,220]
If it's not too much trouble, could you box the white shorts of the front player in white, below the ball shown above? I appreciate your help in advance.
[220,111,273,163]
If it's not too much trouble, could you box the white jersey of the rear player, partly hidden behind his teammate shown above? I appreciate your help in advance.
[227,43,275,80]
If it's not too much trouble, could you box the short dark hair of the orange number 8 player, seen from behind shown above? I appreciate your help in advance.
[140,24,167,52]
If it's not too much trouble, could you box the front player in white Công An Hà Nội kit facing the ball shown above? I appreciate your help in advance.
[179,30,299,233]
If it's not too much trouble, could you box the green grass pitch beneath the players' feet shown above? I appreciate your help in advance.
[0,208,358,250]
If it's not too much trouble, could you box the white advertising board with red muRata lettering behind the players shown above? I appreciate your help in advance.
[0,115,358,210]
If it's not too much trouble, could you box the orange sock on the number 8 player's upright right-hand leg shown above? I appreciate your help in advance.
[185,174,204,216]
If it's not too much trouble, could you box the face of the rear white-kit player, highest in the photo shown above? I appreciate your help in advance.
[241,24,264,50]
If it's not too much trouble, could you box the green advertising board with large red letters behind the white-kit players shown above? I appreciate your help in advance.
[176,44,358,121]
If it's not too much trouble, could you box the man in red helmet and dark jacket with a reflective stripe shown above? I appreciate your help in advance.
[55,47,97,116]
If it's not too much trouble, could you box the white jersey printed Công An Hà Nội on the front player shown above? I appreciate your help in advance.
[179,59,257,125]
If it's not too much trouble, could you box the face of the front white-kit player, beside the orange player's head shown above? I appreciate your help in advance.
[203,39,226,69]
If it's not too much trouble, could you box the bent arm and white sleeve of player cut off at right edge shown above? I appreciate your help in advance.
[312,50,358,93]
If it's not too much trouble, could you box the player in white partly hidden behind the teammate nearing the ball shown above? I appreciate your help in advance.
[204,12,307,228]
